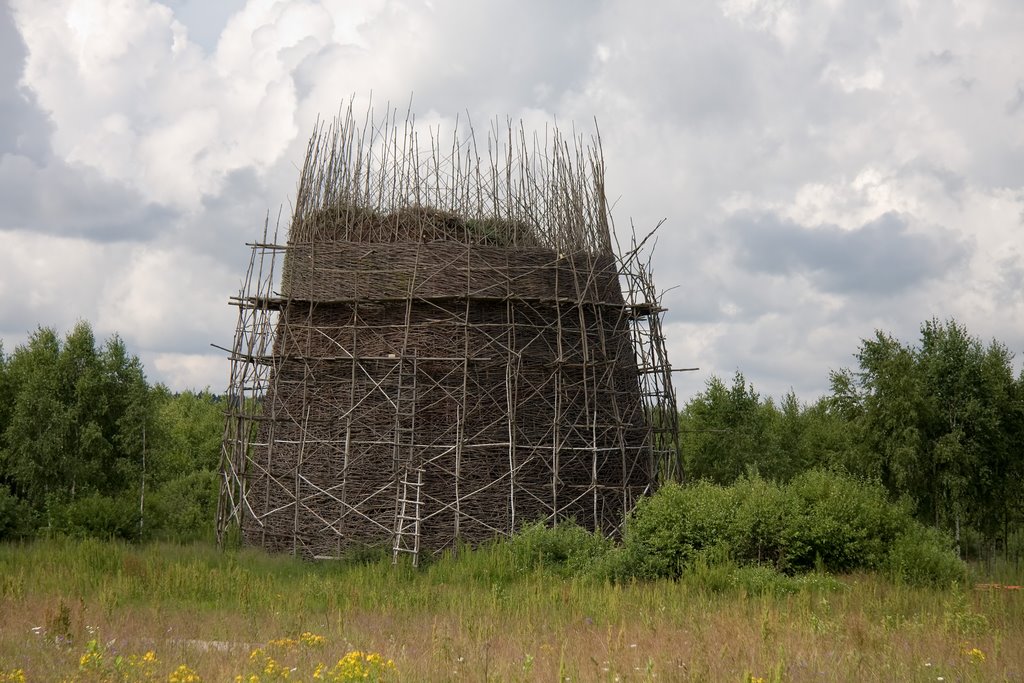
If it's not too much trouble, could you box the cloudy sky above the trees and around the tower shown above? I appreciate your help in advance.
[0,0,1024,400]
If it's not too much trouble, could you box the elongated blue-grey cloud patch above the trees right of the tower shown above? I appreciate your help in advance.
[727,212,971,294]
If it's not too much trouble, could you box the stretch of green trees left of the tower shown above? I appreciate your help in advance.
[0,323,223,539]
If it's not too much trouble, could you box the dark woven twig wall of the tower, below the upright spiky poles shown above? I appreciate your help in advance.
[244,232,653,556]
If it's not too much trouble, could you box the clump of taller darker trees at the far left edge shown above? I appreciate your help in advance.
[0,323,148,512]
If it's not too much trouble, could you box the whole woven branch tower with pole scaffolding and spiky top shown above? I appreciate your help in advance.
[218,102,681,563]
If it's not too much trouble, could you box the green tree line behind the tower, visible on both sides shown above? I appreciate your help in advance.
[0,319,1024,554]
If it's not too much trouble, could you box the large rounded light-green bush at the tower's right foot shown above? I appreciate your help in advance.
[625,470,963,583]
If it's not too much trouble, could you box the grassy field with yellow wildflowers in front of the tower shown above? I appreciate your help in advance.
[0,540,1024,683]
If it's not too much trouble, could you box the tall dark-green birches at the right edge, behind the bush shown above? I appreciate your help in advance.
[831,319,1024,547]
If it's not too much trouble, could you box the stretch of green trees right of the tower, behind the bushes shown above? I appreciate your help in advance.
[680,319,1024,555]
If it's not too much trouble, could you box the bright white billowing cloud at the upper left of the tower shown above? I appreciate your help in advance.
[14,0,301,210]
